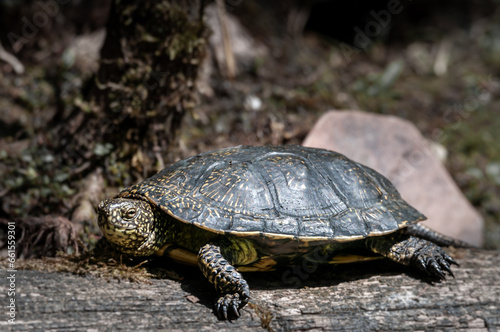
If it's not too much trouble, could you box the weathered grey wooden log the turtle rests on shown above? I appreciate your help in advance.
[0,250,500,331]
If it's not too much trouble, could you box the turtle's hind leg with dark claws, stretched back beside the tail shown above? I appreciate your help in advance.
[367,234,458,280]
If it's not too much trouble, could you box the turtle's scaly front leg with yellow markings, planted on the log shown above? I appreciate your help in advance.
[198,244,250,320]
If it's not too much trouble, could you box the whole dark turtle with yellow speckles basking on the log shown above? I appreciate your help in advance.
[98,145,468,319]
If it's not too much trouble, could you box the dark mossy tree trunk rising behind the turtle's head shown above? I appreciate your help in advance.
[55,0,206,182]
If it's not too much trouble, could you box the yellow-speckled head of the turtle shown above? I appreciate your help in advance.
[97,198,159,256]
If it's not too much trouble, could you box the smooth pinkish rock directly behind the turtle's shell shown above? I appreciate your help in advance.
[304,111,483,246]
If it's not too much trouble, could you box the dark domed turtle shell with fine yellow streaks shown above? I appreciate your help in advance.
[118,145,425,241]
